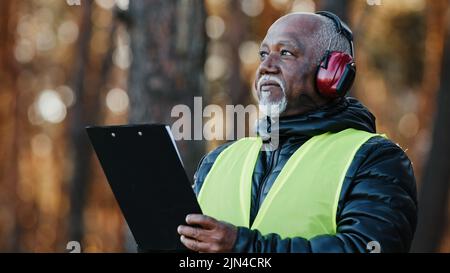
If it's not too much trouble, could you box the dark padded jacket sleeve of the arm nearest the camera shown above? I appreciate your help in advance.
[230,137,417,253]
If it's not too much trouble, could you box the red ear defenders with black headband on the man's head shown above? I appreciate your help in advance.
[315,11,356,98]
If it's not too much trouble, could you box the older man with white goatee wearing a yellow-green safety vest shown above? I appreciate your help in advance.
[178,13,417,252]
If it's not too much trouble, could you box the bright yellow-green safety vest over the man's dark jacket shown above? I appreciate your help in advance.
[198,129,384,239]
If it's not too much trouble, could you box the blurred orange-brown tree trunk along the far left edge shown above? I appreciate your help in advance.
[0,1,23,252]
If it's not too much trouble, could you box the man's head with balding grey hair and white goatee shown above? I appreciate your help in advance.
[255,13,350,116]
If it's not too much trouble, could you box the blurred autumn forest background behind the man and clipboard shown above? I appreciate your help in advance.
[0,0,450,252]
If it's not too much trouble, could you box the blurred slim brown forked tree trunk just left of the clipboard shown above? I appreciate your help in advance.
[69,1,119,246]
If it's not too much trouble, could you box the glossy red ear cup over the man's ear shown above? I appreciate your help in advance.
[316,51,356,98]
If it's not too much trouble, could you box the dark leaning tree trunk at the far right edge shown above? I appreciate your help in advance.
[412,20,450,252]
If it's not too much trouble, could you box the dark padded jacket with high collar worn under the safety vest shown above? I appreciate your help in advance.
[194,98,417,252]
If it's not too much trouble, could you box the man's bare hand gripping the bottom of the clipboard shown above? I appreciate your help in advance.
[178,214,237,252]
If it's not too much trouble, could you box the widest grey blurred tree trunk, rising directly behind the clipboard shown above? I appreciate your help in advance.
[128,0,206,180]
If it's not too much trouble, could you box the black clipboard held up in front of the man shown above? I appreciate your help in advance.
[86,124,201,252]
